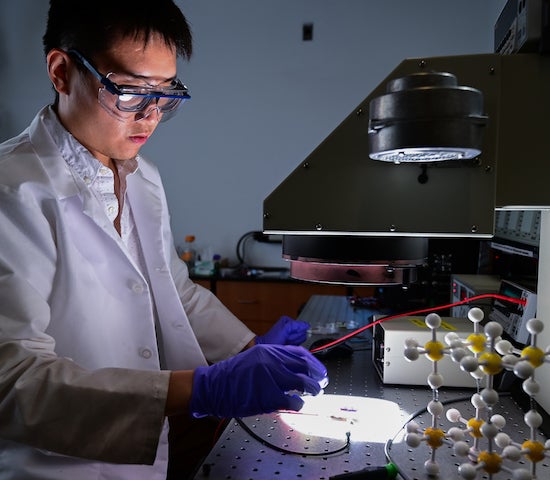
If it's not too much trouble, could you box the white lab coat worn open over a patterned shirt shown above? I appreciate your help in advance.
[0,108,254,480]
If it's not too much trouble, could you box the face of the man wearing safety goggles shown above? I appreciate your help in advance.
[58,36,176,165]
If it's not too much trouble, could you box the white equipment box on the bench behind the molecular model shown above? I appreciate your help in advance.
[372,316,476,388]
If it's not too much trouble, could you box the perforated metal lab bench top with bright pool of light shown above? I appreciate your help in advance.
[194,296,550,480]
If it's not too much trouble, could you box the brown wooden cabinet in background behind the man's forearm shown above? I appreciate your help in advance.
[216,280,373,335]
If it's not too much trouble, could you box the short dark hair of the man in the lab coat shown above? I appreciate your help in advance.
[43,0,192,59]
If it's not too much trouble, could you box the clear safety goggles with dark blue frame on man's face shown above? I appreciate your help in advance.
[68,50,191,122]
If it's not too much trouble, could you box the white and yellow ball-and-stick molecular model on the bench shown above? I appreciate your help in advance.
[404,307,550,480]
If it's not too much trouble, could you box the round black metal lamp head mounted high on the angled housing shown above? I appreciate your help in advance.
[368,72,487,164]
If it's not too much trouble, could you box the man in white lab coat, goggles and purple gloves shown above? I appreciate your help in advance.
[0,0,326,480]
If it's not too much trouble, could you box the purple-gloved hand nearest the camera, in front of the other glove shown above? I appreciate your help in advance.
[189,345,328,418]
